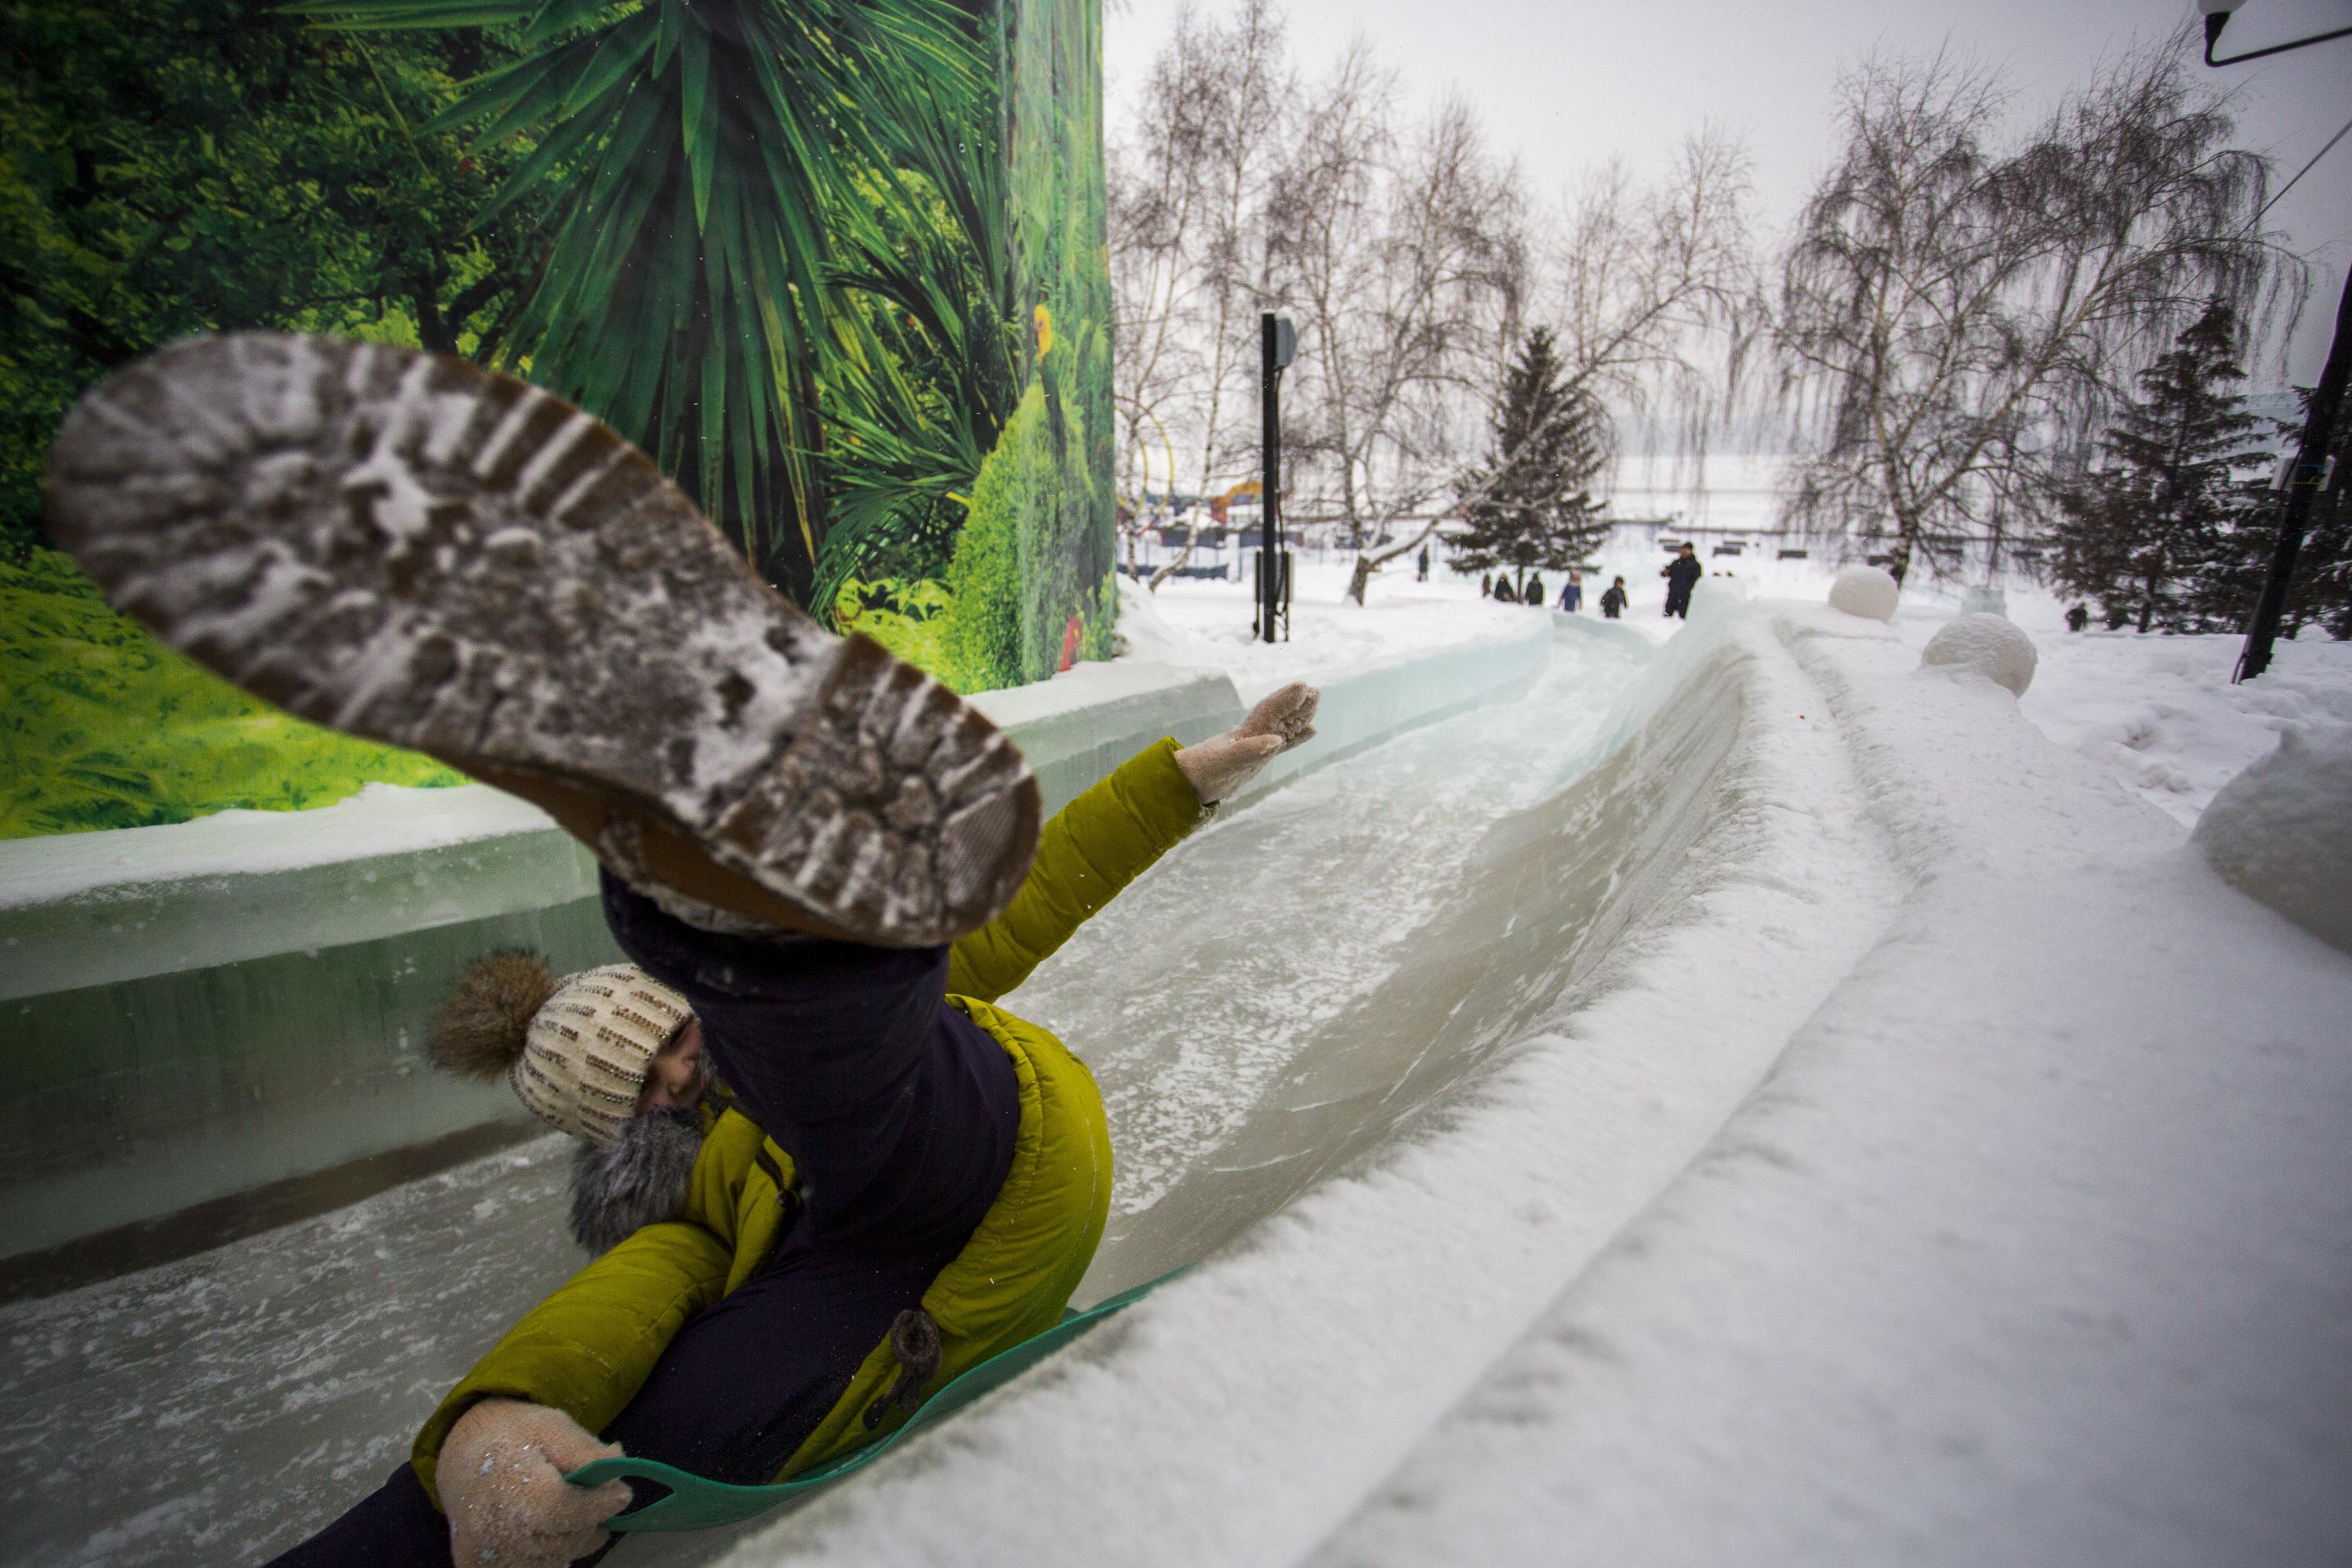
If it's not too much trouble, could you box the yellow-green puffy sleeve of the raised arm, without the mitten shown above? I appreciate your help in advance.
[948,741,1202,1001]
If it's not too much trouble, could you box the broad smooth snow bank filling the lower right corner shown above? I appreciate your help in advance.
[1315,609,2352,1568]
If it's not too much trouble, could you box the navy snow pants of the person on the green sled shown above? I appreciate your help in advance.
[275,874,1021,1568]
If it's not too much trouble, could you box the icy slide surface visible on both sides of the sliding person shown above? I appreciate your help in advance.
[0,623,1665,1563]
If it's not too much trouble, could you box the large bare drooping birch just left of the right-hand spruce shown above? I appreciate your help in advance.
[1773,47,2300,579]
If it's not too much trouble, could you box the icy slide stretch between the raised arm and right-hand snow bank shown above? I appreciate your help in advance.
[1058,626,1743,1300]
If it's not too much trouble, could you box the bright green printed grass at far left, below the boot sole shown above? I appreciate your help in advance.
[0,550,466,839]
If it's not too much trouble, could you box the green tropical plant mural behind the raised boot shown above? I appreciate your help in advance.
[0,0,1117,837]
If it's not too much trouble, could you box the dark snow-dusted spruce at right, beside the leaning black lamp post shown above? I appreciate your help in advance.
[2056,301,2263,633]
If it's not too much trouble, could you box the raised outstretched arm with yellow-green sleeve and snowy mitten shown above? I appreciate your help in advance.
[948,682,1322,1001]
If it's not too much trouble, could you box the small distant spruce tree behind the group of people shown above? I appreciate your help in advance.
[1454,327,1609,600]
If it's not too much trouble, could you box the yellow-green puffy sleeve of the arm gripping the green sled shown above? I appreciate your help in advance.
[409,1220,729,1507]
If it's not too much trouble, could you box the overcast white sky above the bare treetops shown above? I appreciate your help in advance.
[1103,0,2352,386]
